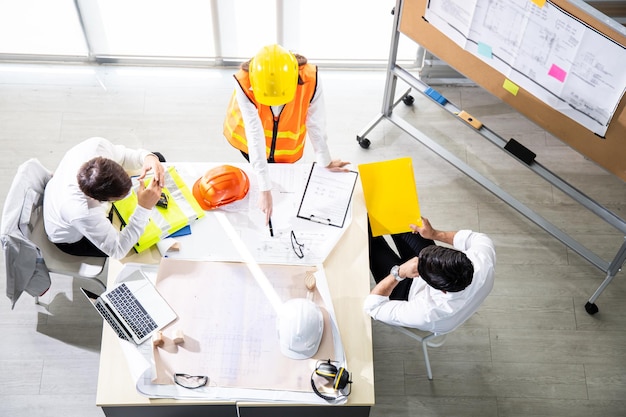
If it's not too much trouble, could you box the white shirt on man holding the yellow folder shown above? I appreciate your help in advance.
[364,230,496,333]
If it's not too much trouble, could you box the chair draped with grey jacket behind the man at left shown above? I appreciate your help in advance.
[0,158,107,306]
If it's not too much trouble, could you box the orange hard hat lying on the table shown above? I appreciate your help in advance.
[193,165,250,210]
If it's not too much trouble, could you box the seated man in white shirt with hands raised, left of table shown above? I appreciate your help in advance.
[44,138,165,259]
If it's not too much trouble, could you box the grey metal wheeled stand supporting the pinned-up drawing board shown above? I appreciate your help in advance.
[356,0,626,314]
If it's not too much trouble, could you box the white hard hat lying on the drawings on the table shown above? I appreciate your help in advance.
[277,298,324,359]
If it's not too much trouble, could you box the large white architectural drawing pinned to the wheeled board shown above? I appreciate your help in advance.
[424,0,626,136]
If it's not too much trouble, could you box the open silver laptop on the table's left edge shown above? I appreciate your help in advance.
[80,270,177,344]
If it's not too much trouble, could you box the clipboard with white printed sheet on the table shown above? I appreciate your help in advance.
[297,162,359,228]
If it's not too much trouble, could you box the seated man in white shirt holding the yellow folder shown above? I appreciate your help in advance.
[364,218,496,333]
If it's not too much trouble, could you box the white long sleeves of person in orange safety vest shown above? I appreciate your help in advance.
[235,76,331,191]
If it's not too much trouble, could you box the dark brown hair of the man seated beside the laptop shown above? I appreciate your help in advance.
[76,156,132,201]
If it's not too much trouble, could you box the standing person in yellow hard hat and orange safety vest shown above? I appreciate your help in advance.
[224,45,349,224]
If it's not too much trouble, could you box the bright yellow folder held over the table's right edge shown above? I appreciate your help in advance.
[359,157,422,236]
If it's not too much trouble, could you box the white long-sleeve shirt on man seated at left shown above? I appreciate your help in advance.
[44,138,151,259]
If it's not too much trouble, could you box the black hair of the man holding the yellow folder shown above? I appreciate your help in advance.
[417,245,474,292]
